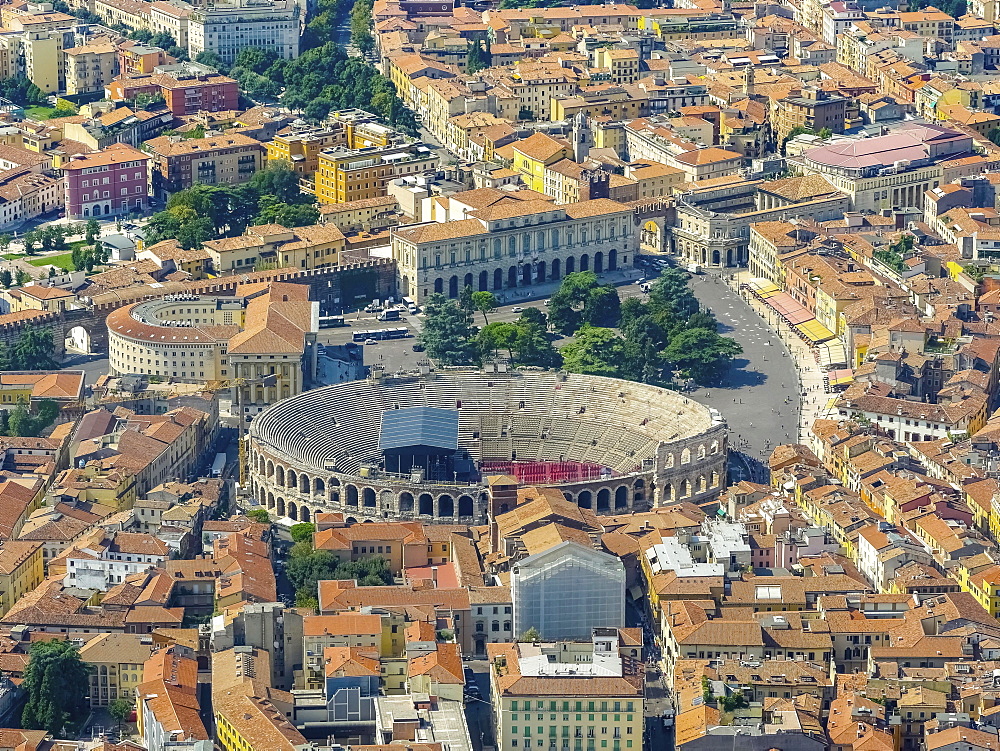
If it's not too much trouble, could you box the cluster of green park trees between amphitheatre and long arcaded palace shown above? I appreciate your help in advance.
[419,269,743,386]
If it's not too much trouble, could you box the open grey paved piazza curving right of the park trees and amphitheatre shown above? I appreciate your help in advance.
[690,274,800,472]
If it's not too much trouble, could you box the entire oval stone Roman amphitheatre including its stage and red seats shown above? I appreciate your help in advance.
[247,368,727,524]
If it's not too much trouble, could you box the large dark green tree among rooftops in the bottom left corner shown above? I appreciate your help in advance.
[21,641,90,737]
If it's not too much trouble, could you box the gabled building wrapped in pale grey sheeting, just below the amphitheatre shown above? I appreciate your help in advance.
[511,540,625,641]
